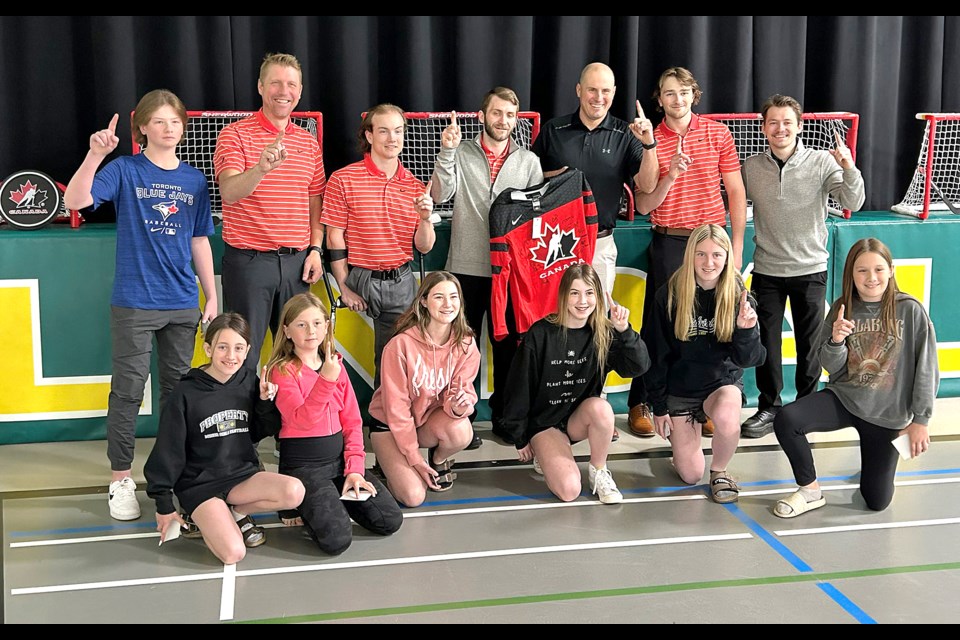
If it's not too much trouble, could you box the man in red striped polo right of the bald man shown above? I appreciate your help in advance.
[628,67,747,437]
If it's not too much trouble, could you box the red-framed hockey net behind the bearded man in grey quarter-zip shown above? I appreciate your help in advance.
[400,111,540,218]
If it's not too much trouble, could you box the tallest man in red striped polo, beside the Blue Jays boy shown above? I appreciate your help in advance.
[213,53,326,370]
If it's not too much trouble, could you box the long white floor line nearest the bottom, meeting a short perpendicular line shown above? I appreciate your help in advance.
[10,533,753,596]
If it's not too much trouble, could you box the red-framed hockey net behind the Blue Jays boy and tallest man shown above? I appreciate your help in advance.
[130,111,323,220]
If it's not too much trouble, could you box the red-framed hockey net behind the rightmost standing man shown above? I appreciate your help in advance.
[701,111,860,218]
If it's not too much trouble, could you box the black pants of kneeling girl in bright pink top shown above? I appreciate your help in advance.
[280,439,403,556]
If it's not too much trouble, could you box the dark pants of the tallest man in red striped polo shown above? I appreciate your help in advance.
[220,244,310,373]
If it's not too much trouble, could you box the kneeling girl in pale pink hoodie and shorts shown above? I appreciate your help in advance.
[372,271,480,507]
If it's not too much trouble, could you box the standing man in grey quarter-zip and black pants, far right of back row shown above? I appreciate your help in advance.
[740,94,864,438]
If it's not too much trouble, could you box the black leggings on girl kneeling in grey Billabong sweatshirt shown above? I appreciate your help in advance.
[773,389,900,511]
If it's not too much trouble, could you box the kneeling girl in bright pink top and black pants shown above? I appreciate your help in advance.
[267,293,403,555]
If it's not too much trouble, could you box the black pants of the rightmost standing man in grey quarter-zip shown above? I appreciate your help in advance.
[750,271,827,410]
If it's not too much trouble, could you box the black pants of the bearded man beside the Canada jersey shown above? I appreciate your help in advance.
[456,274,521,423]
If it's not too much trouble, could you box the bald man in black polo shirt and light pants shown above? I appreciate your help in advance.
[533,62,660,294]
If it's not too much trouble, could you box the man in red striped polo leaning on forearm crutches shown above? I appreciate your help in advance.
[321,104,437,388]
